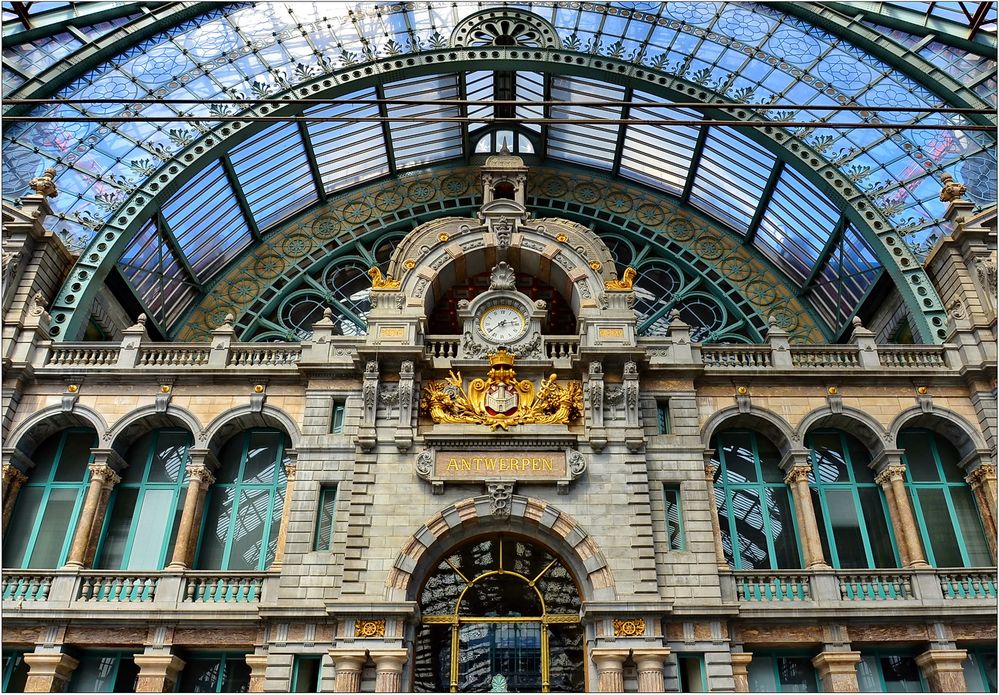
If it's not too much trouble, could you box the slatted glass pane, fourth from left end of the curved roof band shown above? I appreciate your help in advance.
[305,89,389,193]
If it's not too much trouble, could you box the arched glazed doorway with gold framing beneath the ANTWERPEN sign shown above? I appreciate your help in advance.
[413,534,585,692]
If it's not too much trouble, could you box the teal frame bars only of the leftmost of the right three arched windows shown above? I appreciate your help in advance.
[713,429,803,570]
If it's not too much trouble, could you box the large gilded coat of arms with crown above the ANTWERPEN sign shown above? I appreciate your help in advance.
[420,348,583,430]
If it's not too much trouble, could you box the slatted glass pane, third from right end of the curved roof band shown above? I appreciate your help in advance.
[690,126,777,233]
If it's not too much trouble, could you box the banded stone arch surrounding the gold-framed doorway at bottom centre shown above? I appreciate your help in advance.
[385,495,617,601]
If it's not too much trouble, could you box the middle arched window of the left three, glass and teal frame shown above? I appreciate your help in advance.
[97,429,191,570]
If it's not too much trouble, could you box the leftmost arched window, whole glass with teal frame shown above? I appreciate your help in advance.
[3,428,97,569]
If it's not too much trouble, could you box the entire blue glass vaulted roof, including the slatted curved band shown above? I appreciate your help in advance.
[2,2,996,342]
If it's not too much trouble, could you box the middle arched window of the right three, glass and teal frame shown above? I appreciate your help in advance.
[806,430,898,569]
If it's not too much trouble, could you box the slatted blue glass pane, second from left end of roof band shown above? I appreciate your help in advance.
[163,162,253,280]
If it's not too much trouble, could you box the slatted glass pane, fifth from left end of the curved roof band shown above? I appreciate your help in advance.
[385,74,462,169]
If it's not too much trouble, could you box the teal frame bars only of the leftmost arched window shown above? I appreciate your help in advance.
[3,427,97,569]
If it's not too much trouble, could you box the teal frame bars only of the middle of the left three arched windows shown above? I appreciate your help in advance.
[96,427,194,570]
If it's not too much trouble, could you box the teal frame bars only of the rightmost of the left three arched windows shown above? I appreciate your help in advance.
[194,428,288,572]
